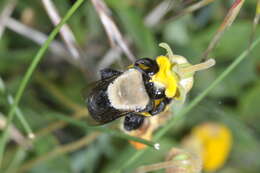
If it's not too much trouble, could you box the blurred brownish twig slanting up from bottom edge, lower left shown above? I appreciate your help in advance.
[19,132,100,173]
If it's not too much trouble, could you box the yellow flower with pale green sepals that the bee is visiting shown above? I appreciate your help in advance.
[156,43,215,101]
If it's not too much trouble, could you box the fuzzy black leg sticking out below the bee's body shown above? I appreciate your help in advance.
[124,113,145,131]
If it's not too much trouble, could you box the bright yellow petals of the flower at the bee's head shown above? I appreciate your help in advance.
[151,56,178,98]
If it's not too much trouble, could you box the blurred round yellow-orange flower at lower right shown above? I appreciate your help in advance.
[182,123,232,171]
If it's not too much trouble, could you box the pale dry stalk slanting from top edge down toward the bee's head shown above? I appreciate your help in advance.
[91,0,135,61]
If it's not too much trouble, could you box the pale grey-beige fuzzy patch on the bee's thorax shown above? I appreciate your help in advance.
[107,69,150,111]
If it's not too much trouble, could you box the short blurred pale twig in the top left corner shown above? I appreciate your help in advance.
[0,0,16,39]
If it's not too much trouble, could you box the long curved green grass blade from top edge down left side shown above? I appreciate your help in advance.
[0,0,84,167]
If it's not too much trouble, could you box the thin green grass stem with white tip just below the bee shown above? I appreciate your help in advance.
[48,114,158,149]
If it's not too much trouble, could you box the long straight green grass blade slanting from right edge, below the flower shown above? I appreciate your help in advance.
[120,32,260,171]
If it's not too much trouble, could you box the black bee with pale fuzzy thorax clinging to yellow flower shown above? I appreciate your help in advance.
[86,58,172,131]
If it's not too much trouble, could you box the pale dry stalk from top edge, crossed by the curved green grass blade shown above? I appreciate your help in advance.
[42,0,80,60]
